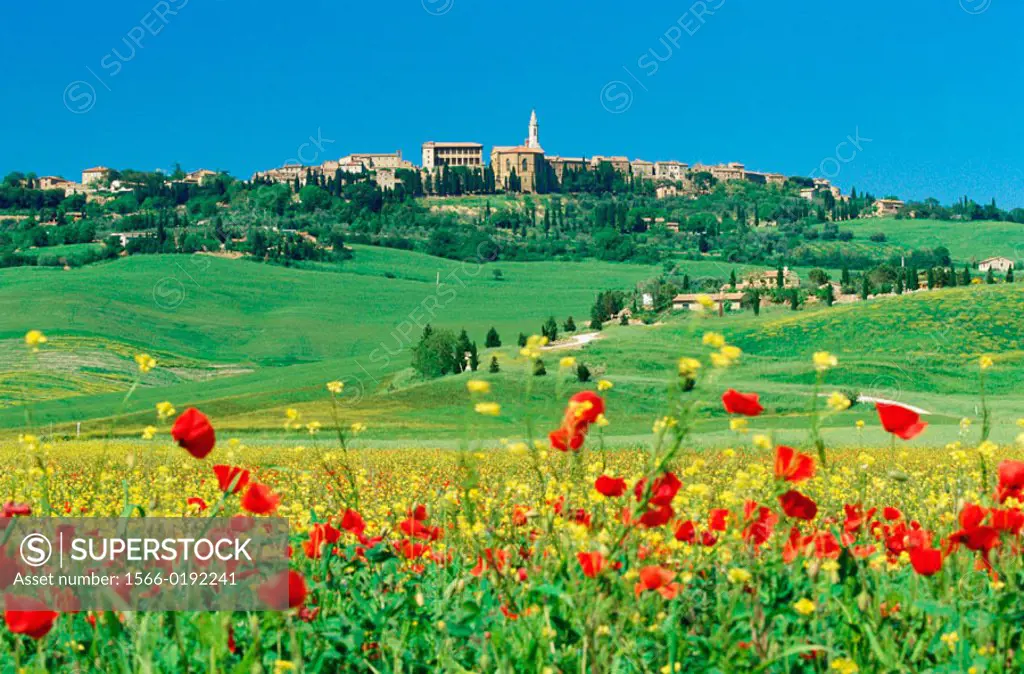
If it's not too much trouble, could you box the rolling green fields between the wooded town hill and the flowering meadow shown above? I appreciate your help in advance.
[0,247,1024,445]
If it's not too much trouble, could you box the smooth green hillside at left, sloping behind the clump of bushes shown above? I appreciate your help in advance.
[0,247,659,427]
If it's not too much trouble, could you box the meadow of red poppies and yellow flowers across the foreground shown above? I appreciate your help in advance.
[0,333,1024,674]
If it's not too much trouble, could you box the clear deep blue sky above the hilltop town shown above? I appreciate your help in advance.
[0,0,1024,207]
